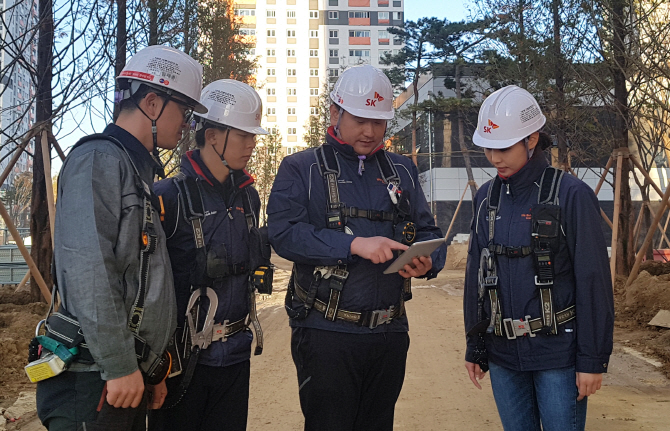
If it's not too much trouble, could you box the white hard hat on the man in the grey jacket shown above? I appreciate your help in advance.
[116,45,207,113]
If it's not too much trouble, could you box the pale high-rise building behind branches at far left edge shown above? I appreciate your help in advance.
[0,0,37,190]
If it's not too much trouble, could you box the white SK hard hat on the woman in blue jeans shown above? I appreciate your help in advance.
[472,85,547,149]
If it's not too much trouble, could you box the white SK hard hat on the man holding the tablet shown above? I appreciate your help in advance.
[330,64,394,120]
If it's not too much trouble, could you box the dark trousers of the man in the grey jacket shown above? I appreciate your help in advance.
[37,371,147,431]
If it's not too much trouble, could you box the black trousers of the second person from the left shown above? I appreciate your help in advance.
[149,360,249,431]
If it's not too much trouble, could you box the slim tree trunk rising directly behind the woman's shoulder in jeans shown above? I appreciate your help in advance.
[551,0,569,170]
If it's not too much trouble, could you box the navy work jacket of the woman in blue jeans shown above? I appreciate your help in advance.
[463,153,614,373]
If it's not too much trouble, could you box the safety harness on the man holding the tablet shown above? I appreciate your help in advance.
[285,143,416,329]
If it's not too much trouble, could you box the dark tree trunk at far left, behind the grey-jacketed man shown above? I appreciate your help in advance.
[30,0,54,301]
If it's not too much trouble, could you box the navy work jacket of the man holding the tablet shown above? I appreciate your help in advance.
[267,127,446,333]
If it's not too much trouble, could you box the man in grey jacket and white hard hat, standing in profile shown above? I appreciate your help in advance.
[37,46,206,430]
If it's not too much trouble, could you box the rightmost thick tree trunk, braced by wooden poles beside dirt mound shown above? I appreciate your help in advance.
[610,0,635,275]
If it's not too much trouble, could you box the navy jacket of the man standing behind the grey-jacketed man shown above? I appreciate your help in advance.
[155,150,260,367]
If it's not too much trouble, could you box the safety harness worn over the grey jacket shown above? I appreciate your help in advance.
[30,134,171,384]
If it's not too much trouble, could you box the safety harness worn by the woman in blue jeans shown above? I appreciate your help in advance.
[486,166,575,340]
